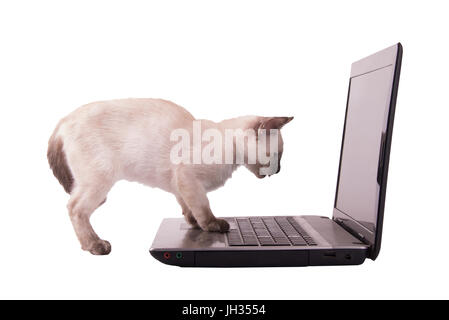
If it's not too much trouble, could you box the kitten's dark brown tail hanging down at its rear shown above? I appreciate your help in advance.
[47,126,74,194]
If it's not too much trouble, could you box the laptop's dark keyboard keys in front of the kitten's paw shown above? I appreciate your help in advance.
[226,217,316,246]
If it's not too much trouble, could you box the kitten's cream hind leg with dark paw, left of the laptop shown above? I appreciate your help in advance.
[67,183,112,255]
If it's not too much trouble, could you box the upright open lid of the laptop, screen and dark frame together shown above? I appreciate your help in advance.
[333,43,402,259]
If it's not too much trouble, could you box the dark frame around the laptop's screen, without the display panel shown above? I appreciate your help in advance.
[333,43,403,260]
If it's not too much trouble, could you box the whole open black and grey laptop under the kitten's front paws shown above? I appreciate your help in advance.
[150,43,402,267]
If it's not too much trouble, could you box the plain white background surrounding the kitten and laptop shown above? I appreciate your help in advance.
[0,0,449,299]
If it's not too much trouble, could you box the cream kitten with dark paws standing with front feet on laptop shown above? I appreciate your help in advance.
[47,99,293,255]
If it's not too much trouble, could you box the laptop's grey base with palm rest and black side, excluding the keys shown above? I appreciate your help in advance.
[150,216,369,267]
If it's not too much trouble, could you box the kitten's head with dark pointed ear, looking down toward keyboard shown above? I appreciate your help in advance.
[245,117,293,179]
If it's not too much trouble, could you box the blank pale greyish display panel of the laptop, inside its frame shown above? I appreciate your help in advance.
[335,65,394,233]
